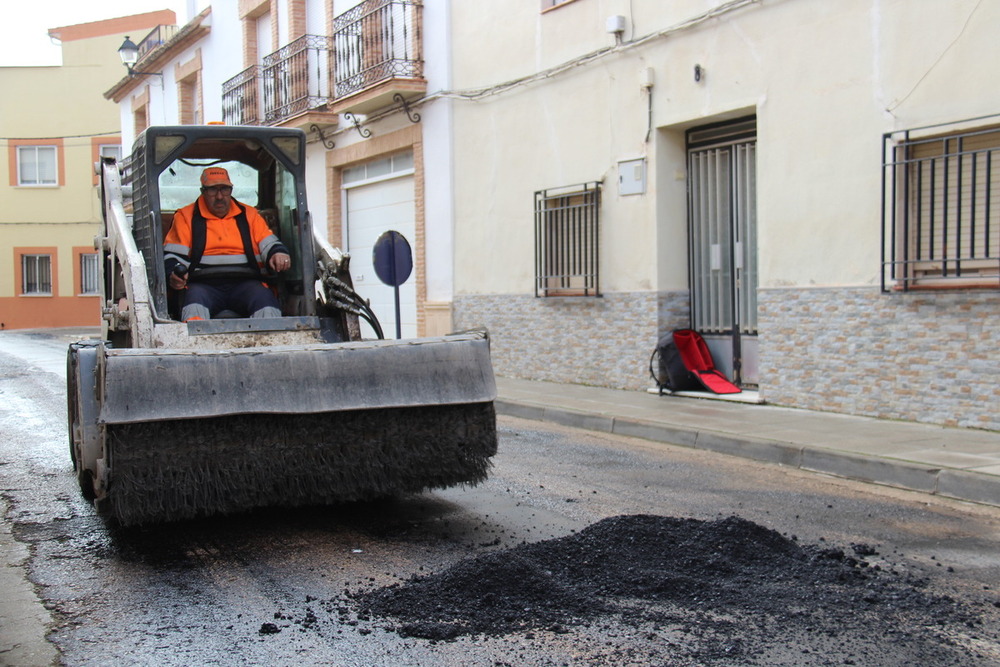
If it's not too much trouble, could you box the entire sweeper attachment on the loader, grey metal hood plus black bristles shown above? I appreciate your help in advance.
[68,332,497,526]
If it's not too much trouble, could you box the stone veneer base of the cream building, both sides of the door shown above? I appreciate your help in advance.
[454,288,1000,430]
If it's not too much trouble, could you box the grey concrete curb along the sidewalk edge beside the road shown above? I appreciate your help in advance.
[495,398,1000,507]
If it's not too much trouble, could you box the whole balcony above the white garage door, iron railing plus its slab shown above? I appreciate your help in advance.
[333,0,427,113]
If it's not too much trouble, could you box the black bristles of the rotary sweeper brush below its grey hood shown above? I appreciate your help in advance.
[100,404,496,526]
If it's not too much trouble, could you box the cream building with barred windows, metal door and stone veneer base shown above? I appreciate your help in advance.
[448,0,1000,429]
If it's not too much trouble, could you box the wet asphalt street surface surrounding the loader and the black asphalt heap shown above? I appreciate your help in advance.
[0,332,1000,666]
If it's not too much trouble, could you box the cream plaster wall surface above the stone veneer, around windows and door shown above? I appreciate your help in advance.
[453,0,1000,294]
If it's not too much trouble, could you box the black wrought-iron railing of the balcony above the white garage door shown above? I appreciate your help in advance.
[333,0,423,100]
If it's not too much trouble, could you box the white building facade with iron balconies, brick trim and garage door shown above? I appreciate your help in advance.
[106,0,453,337]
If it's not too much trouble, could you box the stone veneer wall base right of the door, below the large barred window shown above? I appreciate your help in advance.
[758,288,1000,430]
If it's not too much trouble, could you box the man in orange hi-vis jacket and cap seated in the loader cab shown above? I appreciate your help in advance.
[163,167,292,322]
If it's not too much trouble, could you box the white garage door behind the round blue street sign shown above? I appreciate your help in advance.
[344,153,417,338]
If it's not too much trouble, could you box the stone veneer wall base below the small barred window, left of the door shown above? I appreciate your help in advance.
[454,292,688,389]
